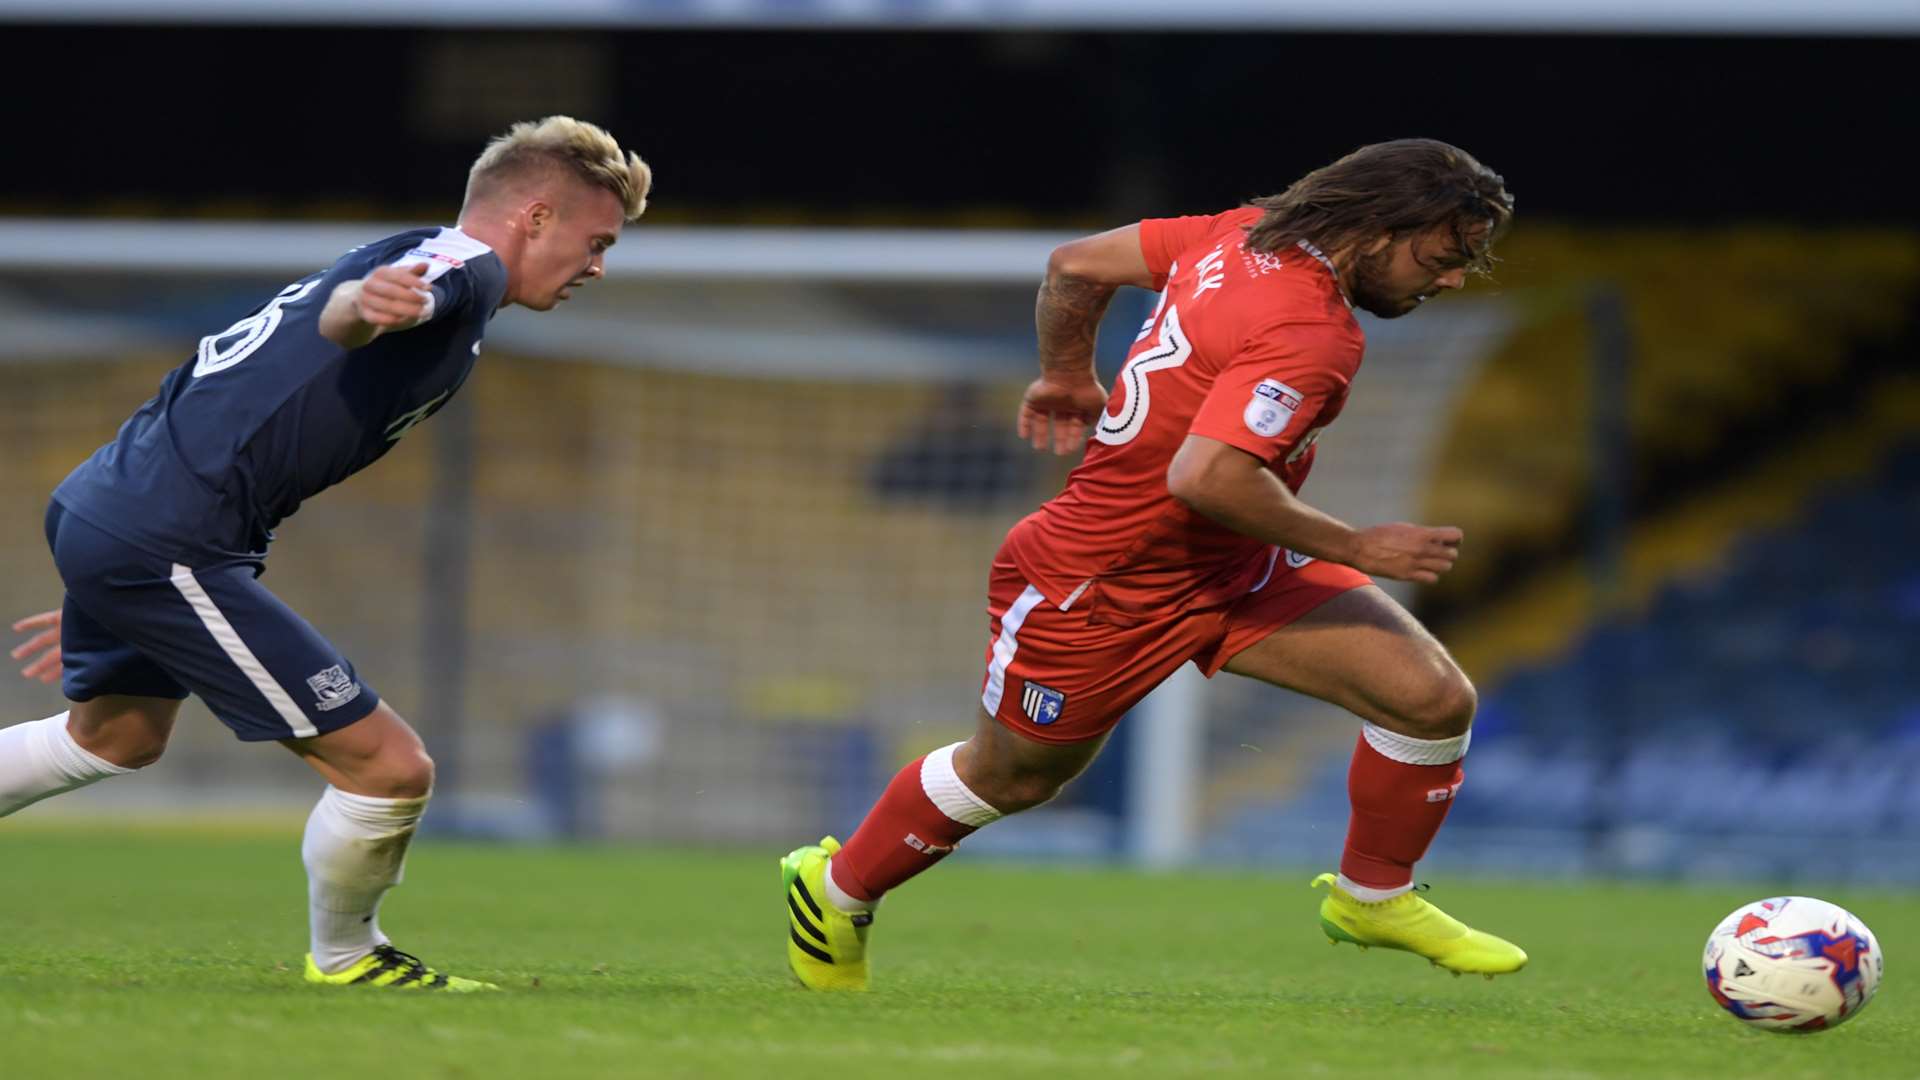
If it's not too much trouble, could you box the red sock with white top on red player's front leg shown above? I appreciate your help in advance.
[1340,724,1467,888]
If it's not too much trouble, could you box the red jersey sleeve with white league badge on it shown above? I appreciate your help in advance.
[1188,315,1359,457]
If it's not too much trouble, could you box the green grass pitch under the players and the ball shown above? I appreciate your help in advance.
[0,819,1920,1080]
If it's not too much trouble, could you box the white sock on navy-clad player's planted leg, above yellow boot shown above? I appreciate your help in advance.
[300,786,426,974]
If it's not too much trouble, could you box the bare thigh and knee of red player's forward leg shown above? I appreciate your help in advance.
[1221,584,1473,738]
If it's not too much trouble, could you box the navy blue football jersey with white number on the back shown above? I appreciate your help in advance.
[54,229,507,567]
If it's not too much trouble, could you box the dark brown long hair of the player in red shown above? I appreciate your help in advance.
[1246,138,1513,273]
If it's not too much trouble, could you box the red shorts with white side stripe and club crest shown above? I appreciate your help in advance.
[981,552,1373,742]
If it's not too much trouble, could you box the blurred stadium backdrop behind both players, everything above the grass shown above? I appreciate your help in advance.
[0,0,1920,880]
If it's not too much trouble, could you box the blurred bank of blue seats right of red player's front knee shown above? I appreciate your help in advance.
[1428,442,1920,840]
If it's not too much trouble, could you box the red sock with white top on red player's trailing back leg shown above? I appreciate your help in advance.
[829,742,1000,901]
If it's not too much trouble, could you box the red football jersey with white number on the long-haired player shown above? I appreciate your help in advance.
[1006,208,1365,625]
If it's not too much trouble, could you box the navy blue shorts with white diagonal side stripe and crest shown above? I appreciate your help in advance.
[46,502,380,742]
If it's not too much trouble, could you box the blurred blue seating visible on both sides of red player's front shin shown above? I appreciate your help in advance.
[1210,428,1920,884]
